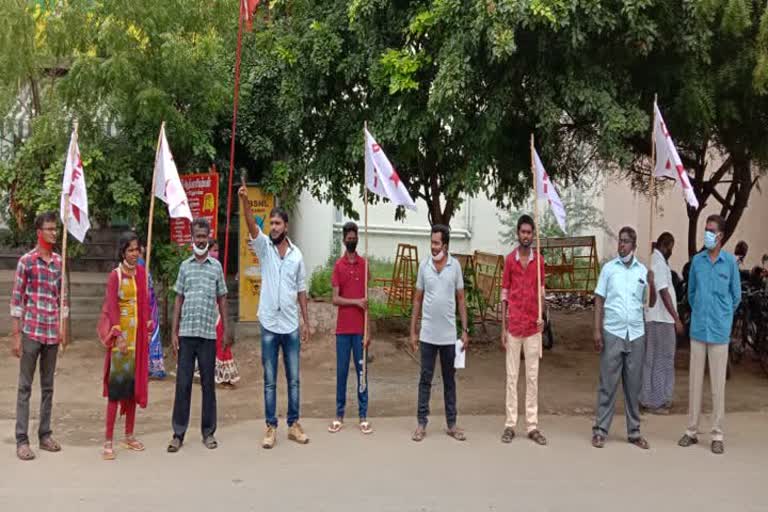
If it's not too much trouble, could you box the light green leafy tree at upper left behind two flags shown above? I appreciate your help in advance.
[0,0,238,240]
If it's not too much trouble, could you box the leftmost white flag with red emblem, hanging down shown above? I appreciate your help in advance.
[60,130,91,243]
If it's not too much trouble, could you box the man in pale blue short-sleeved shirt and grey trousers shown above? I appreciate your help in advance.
[592,226,656,450]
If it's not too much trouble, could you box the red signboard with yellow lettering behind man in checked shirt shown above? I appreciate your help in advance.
[171,173,219,245]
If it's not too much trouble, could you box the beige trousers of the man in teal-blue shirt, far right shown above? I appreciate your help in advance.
[686,339,728,441]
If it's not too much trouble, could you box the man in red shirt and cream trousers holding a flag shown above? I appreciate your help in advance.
[501,215,547,445]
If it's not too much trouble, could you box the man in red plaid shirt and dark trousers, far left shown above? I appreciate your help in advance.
[11,212,68,460]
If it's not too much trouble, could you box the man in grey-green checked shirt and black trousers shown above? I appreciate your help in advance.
[168,219,230,453]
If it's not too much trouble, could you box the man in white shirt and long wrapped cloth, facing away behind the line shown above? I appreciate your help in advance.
[640,232,684,414]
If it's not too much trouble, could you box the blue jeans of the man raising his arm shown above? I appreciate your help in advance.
[261,326,301,427]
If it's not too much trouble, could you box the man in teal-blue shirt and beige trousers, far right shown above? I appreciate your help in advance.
[678,215,741,455]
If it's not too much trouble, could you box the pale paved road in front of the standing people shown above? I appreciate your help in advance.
[0,413,768,512]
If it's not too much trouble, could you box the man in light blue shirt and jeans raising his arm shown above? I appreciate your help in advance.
[238,183,309,449]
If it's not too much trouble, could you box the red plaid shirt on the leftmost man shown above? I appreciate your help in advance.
[11,248,61,345]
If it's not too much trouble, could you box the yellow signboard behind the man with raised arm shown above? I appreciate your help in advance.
[238,187,275,322]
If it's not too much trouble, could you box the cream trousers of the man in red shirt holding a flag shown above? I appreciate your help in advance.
[505,333,541,432]
